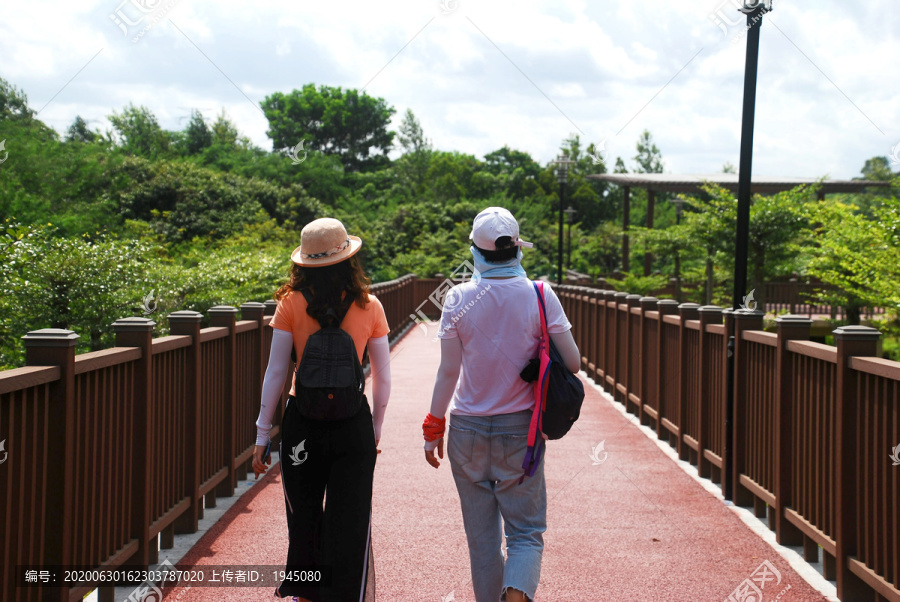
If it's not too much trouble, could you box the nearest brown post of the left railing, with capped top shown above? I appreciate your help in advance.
[22,328,79,602]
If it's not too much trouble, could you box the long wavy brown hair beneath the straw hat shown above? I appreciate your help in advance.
[274,255,371,320]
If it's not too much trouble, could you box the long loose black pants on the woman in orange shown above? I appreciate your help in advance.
[276,400,376,602]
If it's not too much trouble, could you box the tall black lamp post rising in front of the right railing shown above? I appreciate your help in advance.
[722,0,772,500]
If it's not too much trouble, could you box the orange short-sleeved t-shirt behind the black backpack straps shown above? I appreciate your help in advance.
[271,291,391,395]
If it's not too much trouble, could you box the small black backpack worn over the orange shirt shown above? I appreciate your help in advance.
[294,290,368,420]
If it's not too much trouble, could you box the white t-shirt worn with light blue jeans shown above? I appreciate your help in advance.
[438,277,572,416]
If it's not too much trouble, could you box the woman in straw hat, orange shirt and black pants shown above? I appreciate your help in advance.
[253,218,390,602]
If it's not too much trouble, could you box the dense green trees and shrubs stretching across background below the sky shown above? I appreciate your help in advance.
[0,74,900,366]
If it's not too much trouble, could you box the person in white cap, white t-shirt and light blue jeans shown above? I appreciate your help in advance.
[423,207,581,602]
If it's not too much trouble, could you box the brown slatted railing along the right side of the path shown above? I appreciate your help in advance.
[556,285,900,602]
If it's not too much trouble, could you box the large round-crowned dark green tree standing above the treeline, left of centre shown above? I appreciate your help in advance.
[261,84,395,171]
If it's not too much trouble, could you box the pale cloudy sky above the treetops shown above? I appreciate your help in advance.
[0,0,900,178]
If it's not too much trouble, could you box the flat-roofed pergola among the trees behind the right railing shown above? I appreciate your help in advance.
[587,173,891,276]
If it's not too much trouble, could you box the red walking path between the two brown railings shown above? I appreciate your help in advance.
[158,325,828,602]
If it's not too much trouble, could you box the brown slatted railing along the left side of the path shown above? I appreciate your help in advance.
[0,276,418,602]
